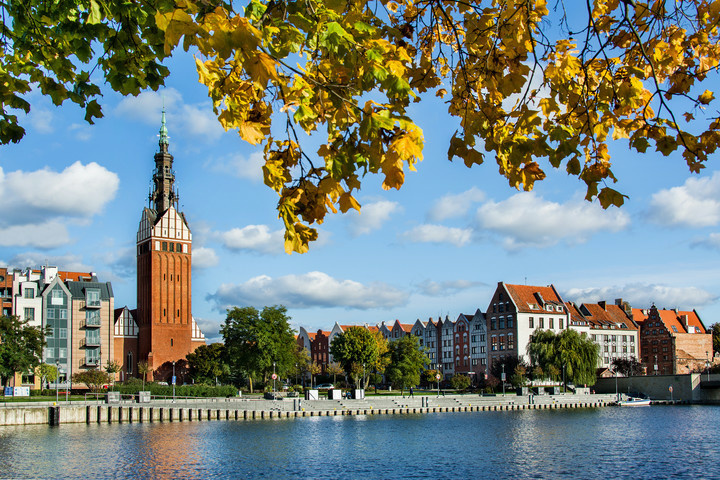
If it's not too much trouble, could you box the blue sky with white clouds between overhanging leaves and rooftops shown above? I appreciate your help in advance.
[0,47,720,342]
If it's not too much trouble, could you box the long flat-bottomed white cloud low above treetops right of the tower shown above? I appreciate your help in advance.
[208,272,408,311]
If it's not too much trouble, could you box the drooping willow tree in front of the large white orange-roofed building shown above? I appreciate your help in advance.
[527,329,600,385]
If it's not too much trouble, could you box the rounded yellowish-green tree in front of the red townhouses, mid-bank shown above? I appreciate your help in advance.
[330,327,379,388]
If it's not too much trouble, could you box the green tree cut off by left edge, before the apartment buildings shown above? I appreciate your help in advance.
[0,315,45,385]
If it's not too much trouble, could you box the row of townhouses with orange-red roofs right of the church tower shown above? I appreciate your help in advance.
[298,282,712,378]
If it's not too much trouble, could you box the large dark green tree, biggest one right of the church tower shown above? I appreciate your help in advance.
[220,305,297,392]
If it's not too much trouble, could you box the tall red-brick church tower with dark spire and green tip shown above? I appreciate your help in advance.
[137,109,194,380]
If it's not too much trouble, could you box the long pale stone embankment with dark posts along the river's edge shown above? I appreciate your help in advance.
[0,394,615,425]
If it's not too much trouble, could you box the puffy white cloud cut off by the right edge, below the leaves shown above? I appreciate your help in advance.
[650,172,720,227]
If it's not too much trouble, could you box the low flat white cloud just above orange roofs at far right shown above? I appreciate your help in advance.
[562,283,718,309]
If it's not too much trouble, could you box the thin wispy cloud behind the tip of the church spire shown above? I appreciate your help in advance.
[115,88,225,141]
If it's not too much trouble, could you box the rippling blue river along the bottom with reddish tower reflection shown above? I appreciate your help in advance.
[0,406,720,479]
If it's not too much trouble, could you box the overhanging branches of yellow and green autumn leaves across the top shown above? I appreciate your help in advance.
[5,0,720,252]
